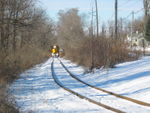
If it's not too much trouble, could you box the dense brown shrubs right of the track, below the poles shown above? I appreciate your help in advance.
[65,38,140,68]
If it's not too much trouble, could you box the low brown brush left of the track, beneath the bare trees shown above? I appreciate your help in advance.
[0,46,49,113]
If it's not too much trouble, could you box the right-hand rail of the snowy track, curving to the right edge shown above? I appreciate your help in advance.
[58,59,150,107]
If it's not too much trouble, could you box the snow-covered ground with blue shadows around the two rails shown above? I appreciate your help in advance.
[10,57,150,113]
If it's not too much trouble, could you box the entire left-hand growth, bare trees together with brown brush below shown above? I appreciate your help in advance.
[0,0,55,113]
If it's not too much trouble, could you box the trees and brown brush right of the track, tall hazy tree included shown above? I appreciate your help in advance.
[56,8,144,68]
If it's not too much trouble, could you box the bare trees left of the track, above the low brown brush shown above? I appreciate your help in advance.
[0,0,52,52]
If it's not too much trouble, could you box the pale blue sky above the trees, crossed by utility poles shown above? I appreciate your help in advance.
[39,0,143,22]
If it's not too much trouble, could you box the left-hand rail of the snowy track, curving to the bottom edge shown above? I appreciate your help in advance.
[51,60,125,113]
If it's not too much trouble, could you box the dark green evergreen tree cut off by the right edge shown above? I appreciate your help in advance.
[145,16,150,41]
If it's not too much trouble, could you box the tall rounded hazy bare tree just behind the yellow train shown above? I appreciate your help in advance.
[58,9,84,48]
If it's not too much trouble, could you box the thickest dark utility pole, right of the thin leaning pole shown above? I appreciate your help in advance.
[115,0,118,39]
